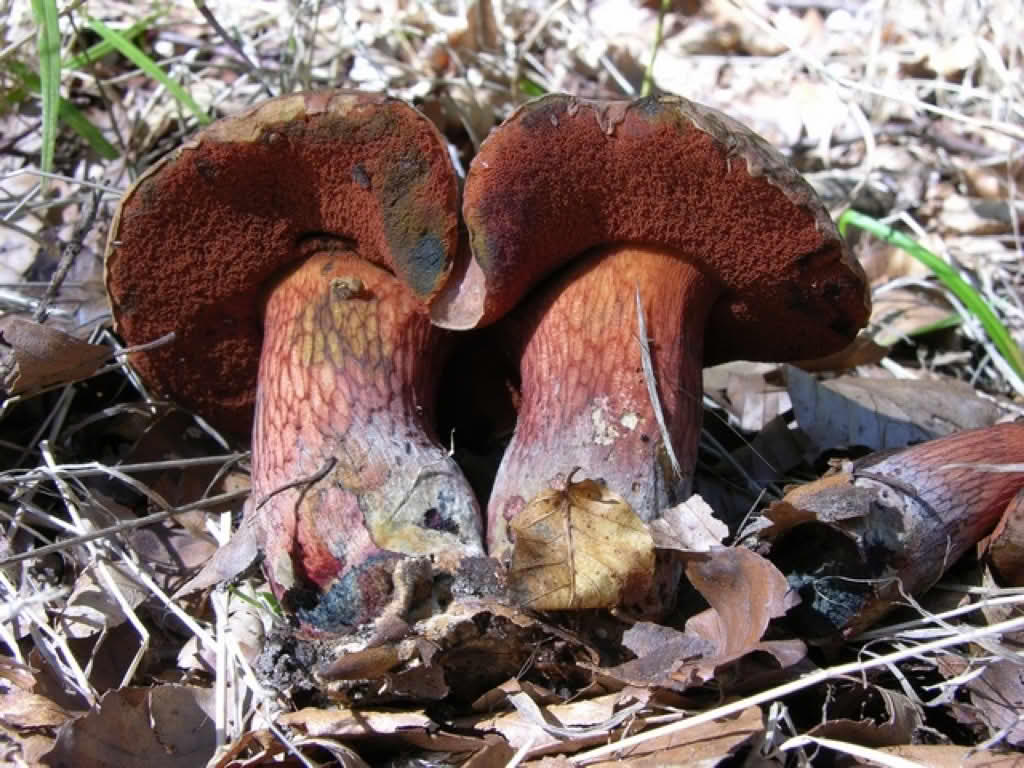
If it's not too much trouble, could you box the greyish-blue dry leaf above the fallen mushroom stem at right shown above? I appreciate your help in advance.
[785,366,1000,451]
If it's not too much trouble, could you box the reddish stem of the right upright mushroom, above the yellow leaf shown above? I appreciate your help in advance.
[487,246,719,557]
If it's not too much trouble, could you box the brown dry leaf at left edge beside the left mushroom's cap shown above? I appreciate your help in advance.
[0,314,113,395]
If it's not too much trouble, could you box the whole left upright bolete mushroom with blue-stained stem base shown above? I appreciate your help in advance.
[106,91,482,630]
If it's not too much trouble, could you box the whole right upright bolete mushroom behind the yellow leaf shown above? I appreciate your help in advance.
[432,95,869,556]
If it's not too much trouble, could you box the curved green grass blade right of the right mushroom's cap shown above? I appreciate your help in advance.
[839,210,1024,379]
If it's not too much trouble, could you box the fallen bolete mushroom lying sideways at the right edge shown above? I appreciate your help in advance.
[761,423,1024,637]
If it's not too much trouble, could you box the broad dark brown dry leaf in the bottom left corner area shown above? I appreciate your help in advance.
[47,685,216,768]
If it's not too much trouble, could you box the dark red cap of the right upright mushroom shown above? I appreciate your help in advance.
[431,94,870,364]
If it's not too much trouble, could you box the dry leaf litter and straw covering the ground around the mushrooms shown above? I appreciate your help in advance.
[0,0,1024,765]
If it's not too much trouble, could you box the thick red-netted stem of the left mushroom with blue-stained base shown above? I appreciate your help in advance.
[253,251,481,631]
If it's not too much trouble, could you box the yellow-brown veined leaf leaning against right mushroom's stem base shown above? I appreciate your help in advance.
[508,476,654,610]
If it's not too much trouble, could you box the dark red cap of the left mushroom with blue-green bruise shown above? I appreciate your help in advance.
[105,90,459,433]
